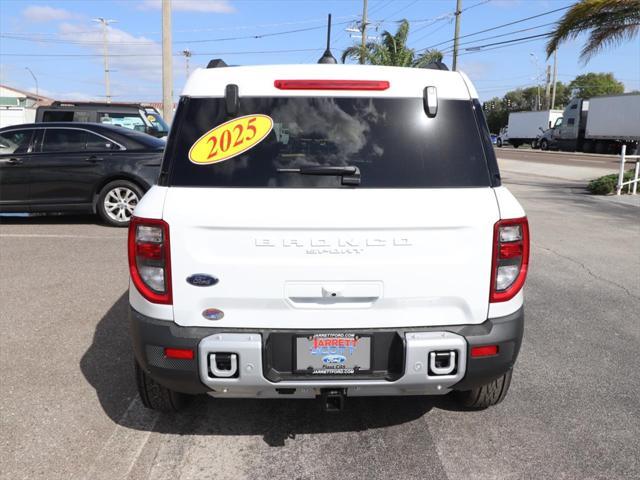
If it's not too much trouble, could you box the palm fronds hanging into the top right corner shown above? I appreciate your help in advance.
[547,0,640,63]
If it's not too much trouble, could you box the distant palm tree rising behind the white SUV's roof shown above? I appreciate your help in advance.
[342,20,442,68]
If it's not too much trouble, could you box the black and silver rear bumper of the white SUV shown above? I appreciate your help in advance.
[130,308,524,398]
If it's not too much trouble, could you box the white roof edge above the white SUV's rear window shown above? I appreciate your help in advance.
[182,64,478,100]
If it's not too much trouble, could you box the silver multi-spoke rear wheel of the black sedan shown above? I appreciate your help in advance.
[96,180,143,227]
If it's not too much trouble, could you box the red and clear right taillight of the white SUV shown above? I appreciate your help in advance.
[489,217,529,302]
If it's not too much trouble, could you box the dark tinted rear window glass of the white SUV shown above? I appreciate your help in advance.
[163,97,491,188]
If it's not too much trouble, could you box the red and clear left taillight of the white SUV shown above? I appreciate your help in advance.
[129,217,172,304]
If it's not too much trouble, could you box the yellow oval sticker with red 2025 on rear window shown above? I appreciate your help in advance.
[189,113,273,165]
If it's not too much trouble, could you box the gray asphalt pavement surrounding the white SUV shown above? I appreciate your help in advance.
[0,150,640,480]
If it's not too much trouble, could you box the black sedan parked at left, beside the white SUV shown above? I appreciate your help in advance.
[0,122,165,226]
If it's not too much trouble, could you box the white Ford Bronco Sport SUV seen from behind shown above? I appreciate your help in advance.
[129,62,529,410]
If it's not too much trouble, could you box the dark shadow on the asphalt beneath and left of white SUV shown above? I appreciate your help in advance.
[80,293,468,446]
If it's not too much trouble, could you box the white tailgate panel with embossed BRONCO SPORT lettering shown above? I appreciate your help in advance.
[163,187,499,329]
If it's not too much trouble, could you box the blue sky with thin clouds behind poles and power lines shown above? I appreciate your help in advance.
[0,0,640,101]
